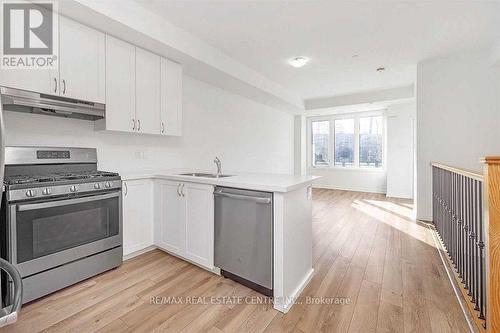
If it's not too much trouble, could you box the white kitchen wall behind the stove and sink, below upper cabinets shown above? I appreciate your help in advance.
[4,76,294,174]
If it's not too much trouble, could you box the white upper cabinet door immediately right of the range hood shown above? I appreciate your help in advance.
[104,36,137,132]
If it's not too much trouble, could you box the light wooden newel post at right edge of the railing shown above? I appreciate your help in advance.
[483,157,500,332]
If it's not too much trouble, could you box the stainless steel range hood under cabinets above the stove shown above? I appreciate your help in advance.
[0,87,106,120]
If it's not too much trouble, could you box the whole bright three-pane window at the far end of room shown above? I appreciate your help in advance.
[308,112,385,169]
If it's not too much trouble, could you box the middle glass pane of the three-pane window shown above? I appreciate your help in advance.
[335,119,354,166]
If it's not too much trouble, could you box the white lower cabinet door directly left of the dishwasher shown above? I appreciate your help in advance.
[182,183,214,269]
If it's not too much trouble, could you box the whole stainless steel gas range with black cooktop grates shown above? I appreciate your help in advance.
[0,147,123,303]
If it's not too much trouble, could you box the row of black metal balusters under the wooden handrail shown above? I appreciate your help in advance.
[432,167,487,327]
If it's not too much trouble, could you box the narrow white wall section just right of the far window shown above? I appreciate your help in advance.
[386,103,416,198]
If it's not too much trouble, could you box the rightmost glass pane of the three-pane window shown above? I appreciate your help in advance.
[359,116,382,168]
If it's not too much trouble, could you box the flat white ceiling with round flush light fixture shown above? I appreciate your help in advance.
[136,0,500,99]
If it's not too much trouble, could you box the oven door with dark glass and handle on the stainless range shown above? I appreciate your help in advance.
[9,191,122,277]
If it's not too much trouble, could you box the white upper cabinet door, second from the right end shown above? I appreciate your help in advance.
[135,48,161,134]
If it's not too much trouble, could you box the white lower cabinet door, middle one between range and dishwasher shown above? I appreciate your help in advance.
[156,181,186,256]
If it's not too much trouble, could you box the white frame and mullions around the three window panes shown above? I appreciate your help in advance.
[307,110,387,172]
